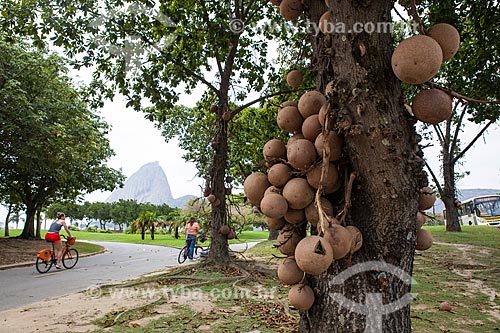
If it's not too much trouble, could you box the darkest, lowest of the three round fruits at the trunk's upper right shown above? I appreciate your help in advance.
[411,89,452,125]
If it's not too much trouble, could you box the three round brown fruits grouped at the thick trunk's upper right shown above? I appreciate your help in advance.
[391,23,460,125]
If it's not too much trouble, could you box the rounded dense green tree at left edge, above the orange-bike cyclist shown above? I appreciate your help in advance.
[0,40,123,237]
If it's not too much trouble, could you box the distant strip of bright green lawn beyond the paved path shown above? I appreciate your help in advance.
[1,230,269,247]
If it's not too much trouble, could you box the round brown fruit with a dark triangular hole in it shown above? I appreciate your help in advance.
[295,236,333,275]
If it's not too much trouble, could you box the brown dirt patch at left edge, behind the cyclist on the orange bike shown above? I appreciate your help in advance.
[0,238,50,266]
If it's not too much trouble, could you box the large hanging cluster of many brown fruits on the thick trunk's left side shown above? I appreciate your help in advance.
[244,70,362,310]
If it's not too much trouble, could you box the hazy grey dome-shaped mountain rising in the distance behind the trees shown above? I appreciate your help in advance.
[106,162,195,207]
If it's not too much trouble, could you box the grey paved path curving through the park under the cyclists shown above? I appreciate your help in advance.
[0,241,257,311]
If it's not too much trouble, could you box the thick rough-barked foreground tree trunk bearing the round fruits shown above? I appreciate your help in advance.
[299,0,427,333]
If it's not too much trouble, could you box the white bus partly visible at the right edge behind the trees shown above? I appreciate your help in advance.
[458,195,500,226]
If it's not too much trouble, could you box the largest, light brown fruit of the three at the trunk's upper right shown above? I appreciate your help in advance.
[390,35,443,84]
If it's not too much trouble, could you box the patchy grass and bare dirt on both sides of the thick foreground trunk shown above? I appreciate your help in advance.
[72,227,500,333]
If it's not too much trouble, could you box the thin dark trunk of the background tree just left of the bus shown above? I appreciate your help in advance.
[441,149,462,232]
